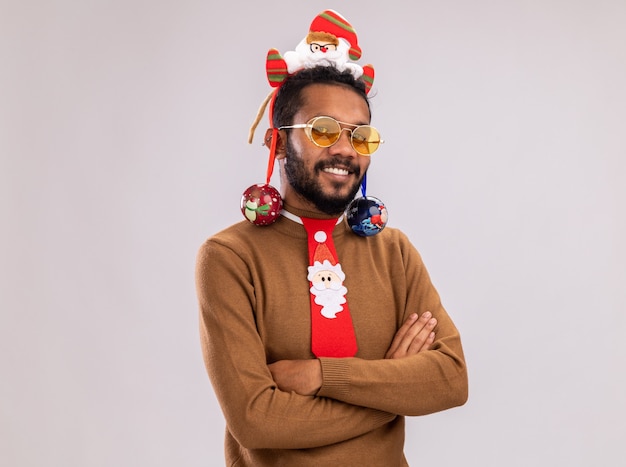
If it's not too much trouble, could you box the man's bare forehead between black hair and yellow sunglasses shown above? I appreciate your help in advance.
[295,84,370,125]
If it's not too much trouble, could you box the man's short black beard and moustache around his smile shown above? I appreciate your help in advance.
[284,138,361,216]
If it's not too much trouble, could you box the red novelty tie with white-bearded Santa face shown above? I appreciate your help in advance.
[301,217,357,357]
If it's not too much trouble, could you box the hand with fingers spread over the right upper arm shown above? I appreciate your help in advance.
[385,311,437,358]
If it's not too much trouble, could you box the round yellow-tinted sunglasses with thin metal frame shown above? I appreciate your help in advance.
[278,117,383,156]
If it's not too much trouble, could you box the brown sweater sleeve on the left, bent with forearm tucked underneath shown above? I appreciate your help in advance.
[196,240,396,449]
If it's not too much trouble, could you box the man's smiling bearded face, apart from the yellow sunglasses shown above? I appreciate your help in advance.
[284,84,370,215]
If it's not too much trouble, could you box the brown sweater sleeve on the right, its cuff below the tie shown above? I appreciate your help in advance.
[318,234,468,415]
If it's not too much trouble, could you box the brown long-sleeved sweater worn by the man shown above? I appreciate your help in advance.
[196,208,467,467]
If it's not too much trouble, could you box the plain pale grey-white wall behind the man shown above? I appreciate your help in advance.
[0,0,626,467]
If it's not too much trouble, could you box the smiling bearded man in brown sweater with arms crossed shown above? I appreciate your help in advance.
[196,12,467,466]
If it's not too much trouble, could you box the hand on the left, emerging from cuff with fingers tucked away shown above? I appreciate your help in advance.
[268,359,322,396]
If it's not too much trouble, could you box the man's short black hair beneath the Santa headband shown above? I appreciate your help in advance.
[272,65,370,128]
